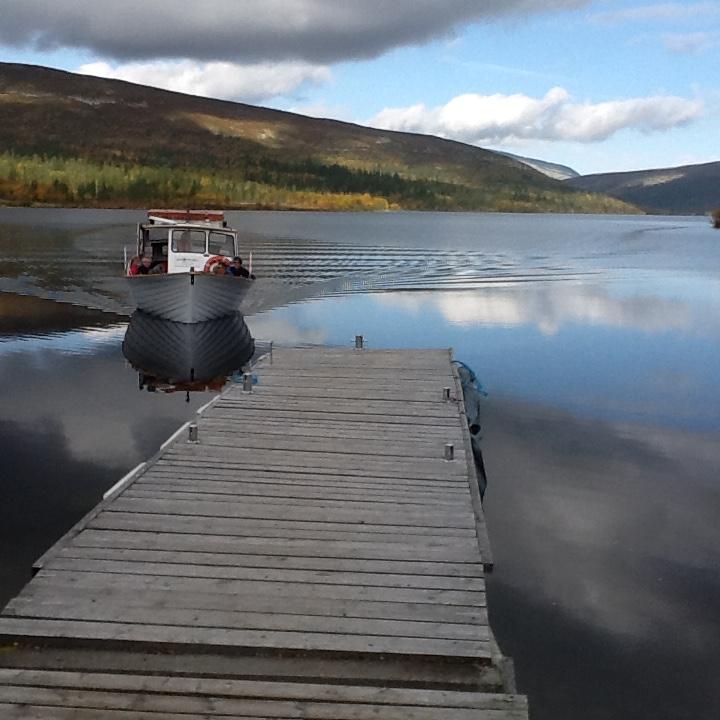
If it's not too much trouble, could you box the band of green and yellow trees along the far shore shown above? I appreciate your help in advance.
[0,152,623,212]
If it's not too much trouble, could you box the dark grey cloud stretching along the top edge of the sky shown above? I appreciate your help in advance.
[0,0,589,64]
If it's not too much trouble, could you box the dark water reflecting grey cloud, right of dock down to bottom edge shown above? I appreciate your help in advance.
[483,397,720,718]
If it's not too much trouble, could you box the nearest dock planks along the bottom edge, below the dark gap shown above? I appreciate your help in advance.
[0,669,527,720]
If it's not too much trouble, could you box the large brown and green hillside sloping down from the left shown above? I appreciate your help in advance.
[0,63,632,212]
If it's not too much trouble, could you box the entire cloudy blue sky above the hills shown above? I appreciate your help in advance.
[0,0,720,174]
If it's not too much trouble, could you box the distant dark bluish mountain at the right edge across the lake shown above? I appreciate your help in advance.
[566,162,720,215]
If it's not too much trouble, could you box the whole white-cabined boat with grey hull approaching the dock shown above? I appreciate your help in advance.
[125,210,254,323]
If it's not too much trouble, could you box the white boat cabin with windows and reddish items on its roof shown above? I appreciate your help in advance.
[126,210,238,275]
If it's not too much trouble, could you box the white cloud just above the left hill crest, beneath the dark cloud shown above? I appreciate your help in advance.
[77,60,330,102]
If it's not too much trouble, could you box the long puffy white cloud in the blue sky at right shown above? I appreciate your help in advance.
[368,87,702,145]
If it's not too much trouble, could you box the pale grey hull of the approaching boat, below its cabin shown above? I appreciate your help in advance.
[126,272,252,323]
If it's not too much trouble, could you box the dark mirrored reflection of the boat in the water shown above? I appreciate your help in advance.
[122,310,255,400]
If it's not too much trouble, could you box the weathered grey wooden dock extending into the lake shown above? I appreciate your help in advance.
[0,349,527,720]
